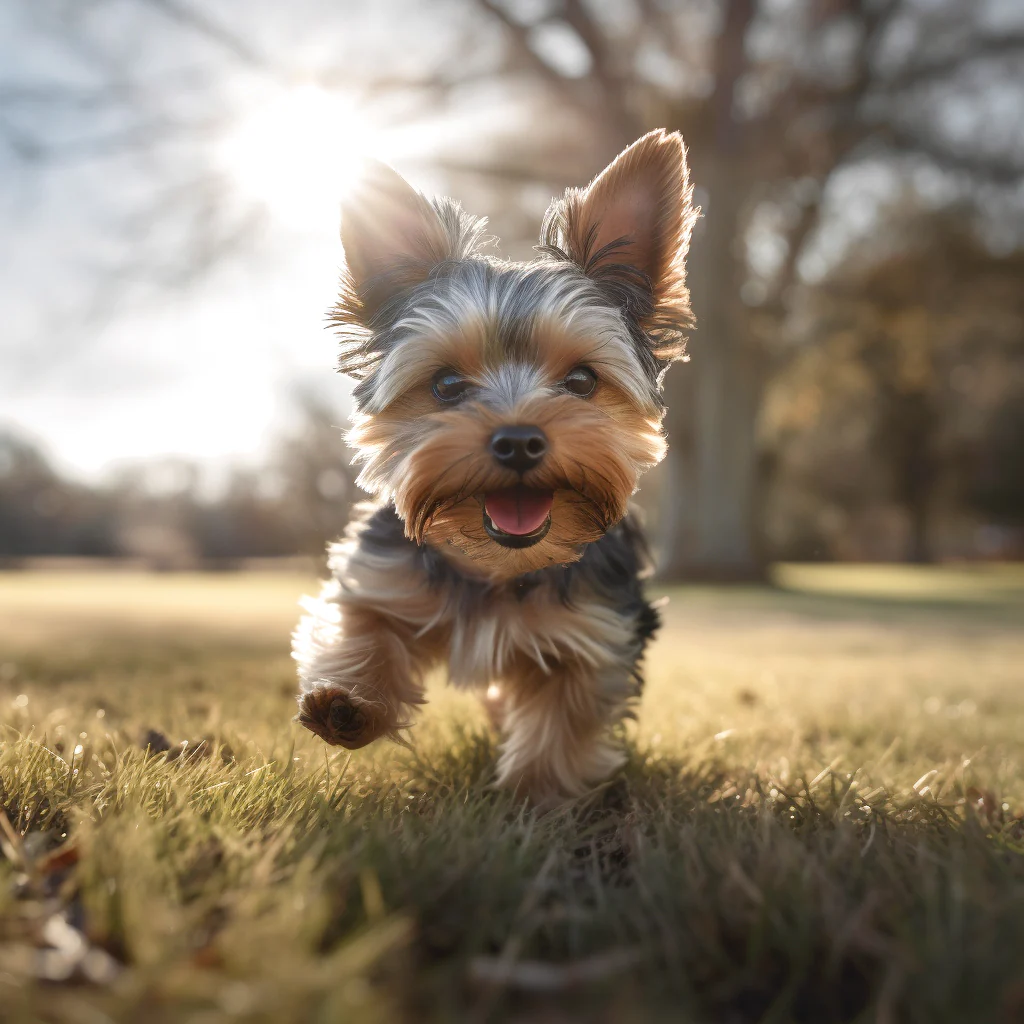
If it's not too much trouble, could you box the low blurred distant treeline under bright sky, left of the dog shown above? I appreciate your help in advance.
[0,391,358,568]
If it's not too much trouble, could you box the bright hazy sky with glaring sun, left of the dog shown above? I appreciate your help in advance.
[0,0,491,480]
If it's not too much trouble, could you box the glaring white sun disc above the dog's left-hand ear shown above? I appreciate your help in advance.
[221,85,388,228]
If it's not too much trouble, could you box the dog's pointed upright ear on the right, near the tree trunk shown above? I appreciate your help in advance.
[541,129,700,360]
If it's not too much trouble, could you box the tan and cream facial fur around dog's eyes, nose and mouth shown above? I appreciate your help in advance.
[349,315,665,581]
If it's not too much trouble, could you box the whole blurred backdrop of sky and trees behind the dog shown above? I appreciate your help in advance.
[0,0,1024,580]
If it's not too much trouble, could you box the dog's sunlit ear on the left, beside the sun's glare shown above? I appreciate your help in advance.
[341,160,451,325]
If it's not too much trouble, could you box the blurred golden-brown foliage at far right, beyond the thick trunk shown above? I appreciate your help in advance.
[762,203,1024,561]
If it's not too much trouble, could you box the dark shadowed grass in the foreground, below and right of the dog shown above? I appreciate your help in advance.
[294,734,1024,1024]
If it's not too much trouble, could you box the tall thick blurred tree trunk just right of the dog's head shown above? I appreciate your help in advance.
[658,0,764,580]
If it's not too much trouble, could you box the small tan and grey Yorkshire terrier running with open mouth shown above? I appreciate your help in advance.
[293,131,698,805]
